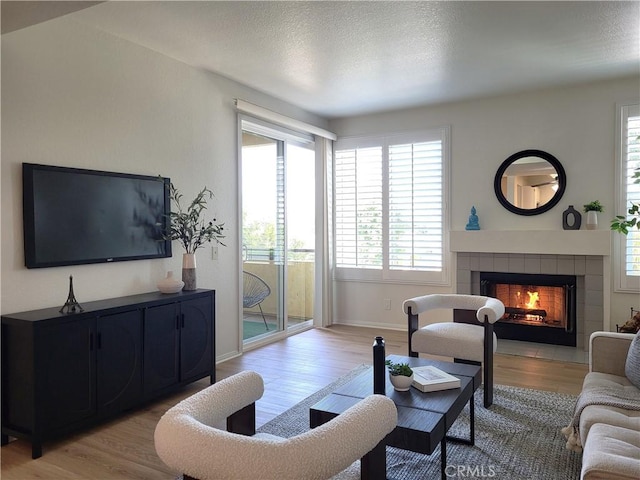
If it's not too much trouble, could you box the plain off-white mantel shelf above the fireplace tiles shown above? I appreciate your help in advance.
[449,230,612,257]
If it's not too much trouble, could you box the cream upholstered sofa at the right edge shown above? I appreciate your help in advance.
[567,332,640,480]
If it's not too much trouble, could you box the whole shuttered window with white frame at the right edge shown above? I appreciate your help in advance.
[615,105,640,292]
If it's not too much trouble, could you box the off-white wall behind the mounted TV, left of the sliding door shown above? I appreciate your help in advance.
[1,17,326,358]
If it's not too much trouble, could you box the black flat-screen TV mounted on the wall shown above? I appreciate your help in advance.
[22,163,171,268]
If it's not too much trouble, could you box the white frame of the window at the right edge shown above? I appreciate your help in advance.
[613,101,640,293]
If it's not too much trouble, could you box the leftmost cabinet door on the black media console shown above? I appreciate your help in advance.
[36,318,96,432]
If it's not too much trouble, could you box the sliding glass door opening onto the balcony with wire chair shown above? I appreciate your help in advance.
[241,119,315,342]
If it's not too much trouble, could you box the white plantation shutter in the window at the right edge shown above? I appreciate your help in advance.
[623,108,640,277]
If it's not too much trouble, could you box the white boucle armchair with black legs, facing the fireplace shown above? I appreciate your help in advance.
[402,294,504,408]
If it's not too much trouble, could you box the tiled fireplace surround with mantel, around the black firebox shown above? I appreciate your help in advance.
[451,231,610,350]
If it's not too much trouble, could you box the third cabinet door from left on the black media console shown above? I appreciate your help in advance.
[144,303,180,396]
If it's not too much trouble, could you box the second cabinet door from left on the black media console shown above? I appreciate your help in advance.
[96,310,142,414]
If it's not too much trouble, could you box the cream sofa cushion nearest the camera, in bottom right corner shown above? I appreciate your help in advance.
[580,423,640,480]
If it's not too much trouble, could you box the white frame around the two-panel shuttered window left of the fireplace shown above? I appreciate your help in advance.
[332,126,451,286]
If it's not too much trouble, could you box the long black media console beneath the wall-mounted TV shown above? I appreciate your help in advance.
[1,290,215,458]
